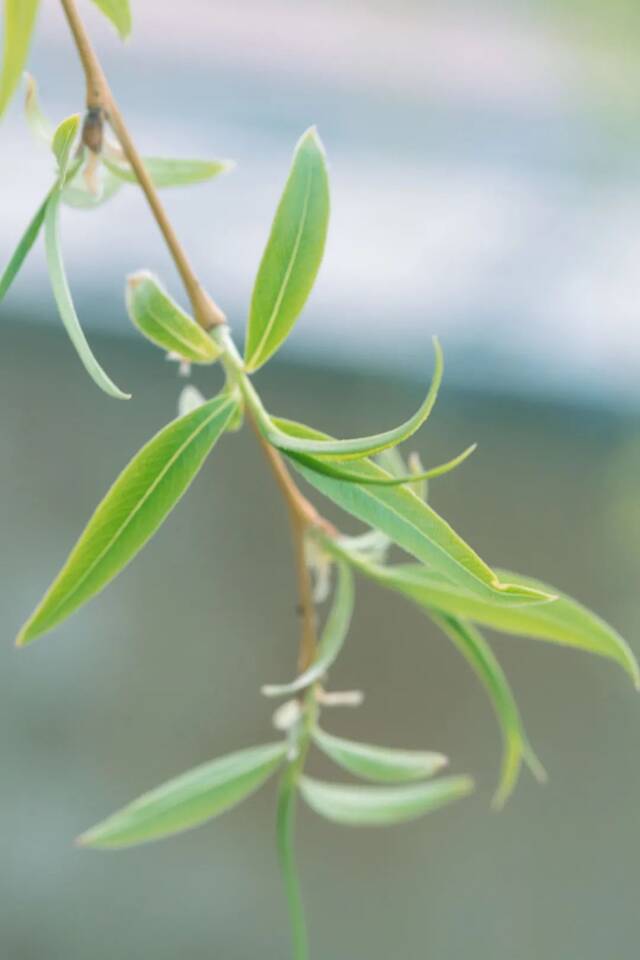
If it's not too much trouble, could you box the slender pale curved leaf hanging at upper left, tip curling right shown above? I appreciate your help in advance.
[44,190,130,400]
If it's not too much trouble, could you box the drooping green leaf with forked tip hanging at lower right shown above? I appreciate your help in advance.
[430,613,546,809]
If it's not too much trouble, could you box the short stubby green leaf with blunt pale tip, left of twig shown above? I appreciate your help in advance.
[127,270,222,363]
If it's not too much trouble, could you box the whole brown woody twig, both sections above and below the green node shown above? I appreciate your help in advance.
[60,0,335,671]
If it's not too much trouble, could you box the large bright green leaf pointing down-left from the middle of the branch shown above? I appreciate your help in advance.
[17,394,236,646]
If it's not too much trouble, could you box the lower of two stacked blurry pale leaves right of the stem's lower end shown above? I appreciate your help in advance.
[300,777,473,827]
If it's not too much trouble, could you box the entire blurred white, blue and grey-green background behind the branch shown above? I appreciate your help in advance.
[0,0,640,960]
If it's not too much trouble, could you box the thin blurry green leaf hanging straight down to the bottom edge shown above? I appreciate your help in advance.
[276,762,309,960]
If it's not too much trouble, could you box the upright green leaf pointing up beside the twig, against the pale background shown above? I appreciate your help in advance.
[244,127,329,370]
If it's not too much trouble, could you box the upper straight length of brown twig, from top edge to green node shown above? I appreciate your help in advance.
[60,0,226,330]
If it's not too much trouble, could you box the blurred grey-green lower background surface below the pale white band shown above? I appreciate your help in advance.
[0,324,640,960]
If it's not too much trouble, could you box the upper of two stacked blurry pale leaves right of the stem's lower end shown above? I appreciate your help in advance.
[312,727,447,783]
